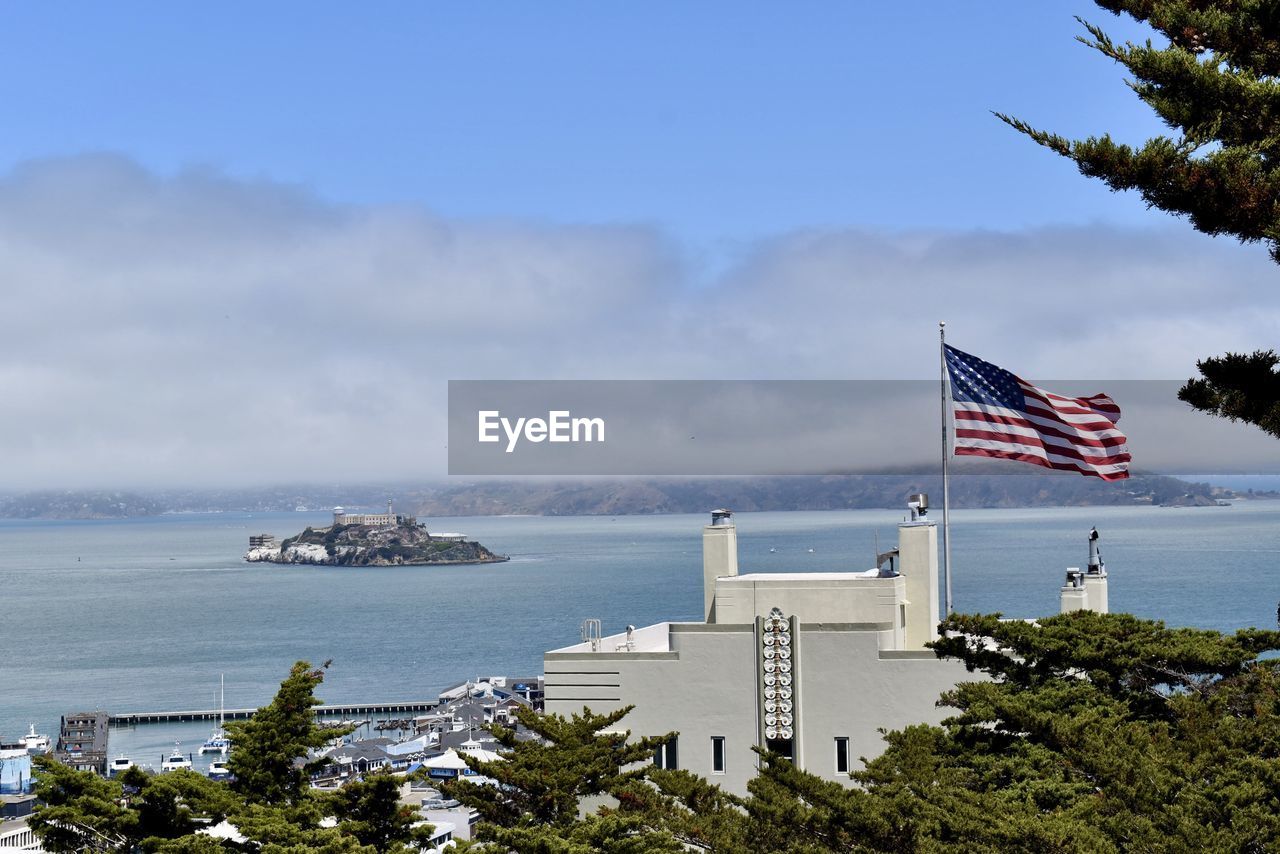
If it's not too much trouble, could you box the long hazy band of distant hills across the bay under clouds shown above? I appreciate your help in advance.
[0,469,1280,519]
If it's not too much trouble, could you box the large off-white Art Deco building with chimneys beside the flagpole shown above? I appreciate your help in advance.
[543,495,1090,794]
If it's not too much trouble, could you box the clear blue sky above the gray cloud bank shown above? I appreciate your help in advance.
[0,1,1158,243]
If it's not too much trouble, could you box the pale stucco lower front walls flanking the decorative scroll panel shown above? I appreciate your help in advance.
[544,622,965,794]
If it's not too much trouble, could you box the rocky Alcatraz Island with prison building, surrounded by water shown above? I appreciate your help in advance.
[244,501,509,566]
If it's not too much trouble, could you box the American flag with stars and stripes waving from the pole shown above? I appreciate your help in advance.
[945,346,1129,480]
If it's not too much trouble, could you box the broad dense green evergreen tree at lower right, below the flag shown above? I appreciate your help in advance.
[856,611,1280,851]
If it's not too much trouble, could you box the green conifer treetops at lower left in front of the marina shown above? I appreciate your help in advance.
[32,662,430,854]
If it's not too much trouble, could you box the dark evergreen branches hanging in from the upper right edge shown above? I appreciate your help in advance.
[996,0,1280,438]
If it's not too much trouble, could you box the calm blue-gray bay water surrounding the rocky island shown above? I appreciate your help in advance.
[0,502,1280,764]
